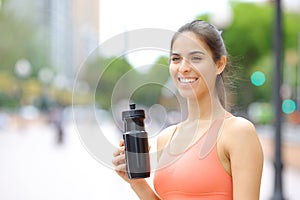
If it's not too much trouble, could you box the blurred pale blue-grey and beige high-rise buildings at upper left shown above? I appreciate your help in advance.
[45,0,99,85]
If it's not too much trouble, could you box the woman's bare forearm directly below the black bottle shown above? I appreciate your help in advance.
[130,179,160,200]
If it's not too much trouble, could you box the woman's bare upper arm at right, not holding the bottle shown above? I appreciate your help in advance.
[226,118,263,200]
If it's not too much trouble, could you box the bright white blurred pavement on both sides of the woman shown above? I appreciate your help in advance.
[0,121,300,200]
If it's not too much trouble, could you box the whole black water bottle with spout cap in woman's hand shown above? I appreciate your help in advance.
[122,104,150,179]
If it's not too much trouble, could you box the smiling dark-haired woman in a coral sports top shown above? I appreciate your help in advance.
[113,20,263,200]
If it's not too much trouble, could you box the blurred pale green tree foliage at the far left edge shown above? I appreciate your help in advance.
[0,1,51,108]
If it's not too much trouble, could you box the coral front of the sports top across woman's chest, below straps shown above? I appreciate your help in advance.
[155,143,232,198]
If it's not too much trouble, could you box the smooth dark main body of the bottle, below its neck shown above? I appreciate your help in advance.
[123,131,150,179]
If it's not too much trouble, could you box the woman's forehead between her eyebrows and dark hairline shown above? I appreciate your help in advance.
[172,32,209,53]
